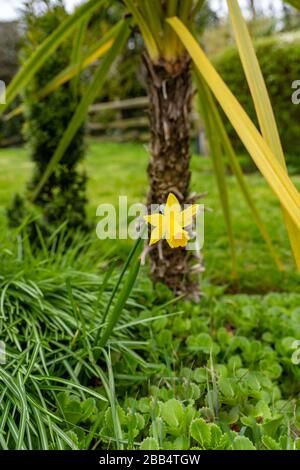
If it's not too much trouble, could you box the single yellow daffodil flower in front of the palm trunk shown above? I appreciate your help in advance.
[144,193,199,248]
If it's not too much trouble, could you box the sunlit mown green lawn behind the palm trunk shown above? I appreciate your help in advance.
[0,141,300,293]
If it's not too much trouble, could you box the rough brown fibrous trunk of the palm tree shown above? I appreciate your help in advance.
[144,56,199,298]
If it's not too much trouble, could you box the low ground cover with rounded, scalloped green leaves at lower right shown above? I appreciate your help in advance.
[92,288,300,450]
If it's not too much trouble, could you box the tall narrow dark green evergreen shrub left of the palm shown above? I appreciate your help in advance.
[10,1,87,234]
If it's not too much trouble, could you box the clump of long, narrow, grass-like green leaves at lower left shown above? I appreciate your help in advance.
[0,228,144,449]
